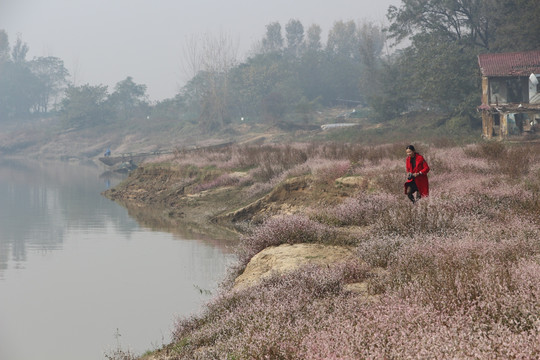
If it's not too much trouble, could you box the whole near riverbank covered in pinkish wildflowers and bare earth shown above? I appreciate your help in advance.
[106,143,540,359]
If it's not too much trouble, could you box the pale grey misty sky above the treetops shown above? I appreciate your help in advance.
[0,0,401,100]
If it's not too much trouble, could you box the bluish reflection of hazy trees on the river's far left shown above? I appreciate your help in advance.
[0,159,137,271]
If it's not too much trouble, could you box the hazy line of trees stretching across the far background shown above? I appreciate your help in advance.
[0,0,540,131]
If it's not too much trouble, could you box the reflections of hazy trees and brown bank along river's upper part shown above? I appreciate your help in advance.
[0,159,237,276]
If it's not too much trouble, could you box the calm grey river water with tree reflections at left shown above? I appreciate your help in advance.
[0,159,236,360]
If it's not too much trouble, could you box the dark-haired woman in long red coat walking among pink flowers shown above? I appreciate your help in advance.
[405,145,429,203]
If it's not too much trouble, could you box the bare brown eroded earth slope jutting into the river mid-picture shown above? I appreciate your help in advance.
[103,163,368,238]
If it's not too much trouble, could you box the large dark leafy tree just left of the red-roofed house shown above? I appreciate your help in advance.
[380,0,502,117]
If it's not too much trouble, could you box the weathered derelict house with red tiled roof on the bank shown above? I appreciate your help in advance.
[478,50,540,139]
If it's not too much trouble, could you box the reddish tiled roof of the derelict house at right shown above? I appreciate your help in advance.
[478,50,540,76]
